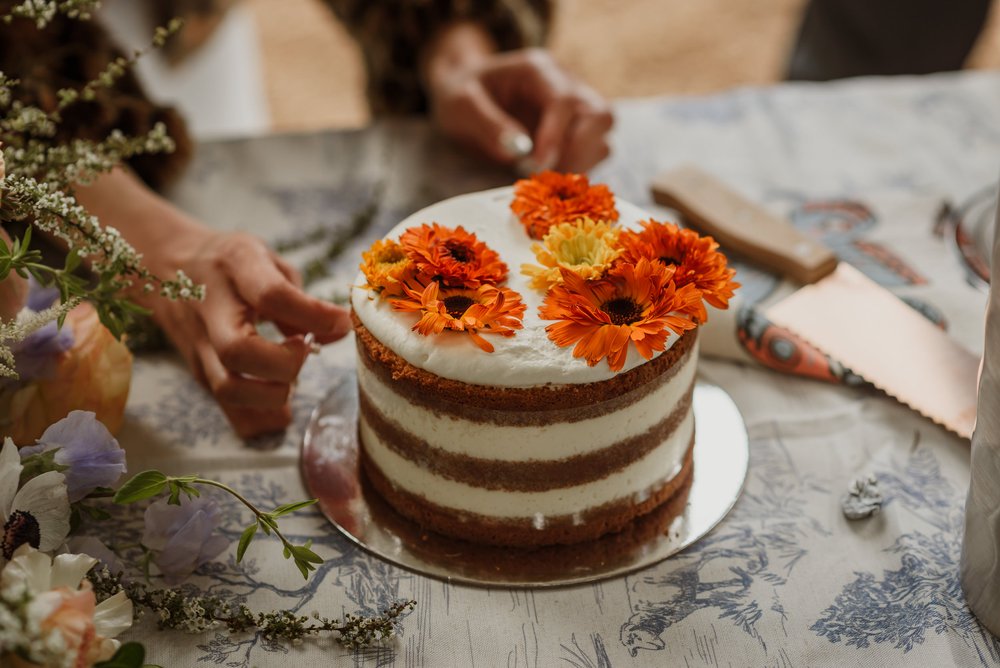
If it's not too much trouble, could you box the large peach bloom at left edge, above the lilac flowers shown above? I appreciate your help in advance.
[0,304,132,445]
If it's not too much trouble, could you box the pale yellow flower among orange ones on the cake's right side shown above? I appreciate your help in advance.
[521,218,621,290]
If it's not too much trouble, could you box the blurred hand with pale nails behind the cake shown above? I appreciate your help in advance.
[425,24,613,172]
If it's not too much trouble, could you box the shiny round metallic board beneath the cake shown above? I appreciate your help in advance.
[301,369,749,588]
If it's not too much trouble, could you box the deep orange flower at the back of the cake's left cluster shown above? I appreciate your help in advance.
[400,223,507,288]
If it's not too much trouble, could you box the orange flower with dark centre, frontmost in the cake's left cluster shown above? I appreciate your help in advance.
[389,281,525,353]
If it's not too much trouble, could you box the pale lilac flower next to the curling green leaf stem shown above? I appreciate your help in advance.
[142,496,229,585]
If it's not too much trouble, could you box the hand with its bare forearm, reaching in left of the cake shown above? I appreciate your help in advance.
[79,172,351,437]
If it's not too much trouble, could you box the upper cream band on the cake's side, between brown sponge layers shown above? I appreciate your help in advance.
[358,347,698,462]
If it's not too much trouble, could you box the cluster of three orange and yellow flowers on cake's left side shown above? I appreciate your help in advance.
[361,223,526,353]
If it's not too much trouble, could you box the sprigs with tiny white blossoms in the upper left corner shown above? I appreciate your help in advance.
[0,13,198,377]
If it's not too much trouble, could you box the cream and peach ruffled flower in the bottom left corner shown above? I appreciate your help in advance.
[0,545,132,666]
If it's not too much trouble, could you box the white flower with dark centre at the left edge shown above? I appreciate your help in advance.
[0,438,70,568]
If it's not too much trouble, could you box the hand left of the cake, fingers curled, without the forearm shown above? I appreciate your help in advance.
[149,230,351,438]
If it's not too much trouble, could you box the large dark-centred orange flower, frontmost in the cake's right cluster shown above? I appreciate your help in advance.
[539,259,701,371]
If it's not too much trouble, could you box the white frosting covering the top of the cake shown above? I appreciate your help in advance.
[351,187,677,387]
